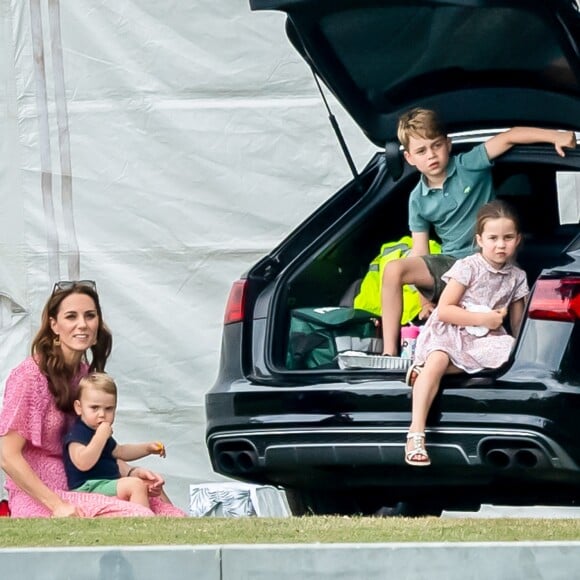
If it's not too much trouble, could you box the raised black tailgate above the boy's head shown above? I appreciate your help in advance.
[250,0,580,146]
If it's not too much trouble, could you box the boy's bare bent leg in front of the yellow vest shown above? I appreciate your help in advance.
[381,256,434,356]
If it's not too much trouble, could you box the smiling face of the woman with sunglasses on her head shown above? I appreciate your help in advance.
[50,293,99,362]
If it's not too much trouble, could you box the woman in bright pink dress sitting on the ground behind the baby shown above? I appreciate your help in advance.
[0,280,185,518]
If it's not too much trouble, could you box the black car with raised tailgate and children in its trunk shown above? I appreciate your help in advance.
[206,0,580,514]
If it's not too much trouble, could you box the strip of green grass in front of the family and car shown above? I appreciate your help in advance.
[0,517,580,548]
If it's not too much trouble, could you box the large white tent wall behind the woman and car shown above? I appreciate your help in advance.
[0,0,373,509]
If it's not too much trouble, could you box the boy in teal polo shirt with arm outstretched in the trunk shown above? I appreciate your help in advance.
[381,108,576,356]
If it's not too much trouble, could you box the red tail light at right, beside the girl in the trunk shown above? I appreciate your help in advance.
[528,277,580,322]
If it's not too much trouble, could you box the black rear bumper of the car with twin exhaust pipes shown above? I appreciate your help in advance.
[206,377,580,504]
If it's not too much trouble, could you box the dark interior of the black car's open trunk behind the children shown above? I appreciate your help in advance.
[272,144,579,368]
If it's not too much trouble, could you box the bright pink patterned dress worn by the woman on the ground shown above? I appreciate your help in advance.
[0,357,185,518]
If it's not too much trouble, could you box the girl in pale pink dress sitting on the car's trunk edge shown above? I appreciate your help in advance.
[405,201,529,466]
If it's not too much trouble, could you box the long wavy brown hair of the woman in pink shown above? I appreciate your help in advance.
[31,283,113,413]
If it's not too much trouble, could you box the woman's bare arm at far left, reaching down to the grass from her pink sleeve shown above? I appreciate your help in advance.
[0,431,83,517]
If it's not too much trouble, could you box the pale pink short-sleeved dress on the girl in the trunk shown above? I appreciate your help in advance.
[415,253,529,373]
